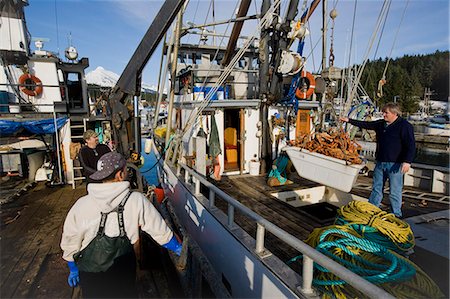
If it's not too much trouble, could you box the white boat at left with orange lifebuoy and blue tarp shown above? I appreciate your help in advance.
[0,1,116,201]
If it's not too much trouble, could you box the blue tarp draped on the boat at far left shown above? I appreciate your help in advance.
[0,117,67,136]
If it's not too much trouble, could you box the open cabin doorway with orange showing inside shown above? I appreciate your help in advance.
[223,109,245,173]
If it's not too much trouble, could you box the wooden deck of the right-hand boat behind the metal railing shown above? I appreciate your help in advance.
[214,174,449,296]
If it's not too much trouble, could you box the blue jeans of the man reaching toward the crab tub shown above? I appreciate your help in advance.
[369,162,403,217]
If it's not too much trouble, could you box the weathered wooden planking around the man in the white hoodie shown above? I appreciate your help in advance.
[0,183,184,298]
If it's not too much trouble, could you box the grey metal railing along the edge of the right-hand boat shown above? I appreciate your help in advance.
[177,163,395,298]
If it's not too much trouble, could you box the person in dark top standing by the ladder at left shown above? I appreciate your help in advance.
[79,130,111,185]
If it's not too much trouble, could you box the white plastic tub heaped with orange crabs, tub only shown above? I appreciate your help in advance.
[283,146,364,192]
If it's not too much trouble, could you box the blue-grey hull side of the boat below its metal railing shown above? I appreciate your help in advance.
[154,144,301,298]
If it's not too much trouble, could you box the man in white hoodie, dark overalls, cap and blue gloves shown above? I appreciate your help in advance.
[61,152,182,298]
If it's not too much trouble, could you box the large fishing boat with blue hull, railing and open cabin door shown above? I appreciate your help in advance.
[132,1,449,298]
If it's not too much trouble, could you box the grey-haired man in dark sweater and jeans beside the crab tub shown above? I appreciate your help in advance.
[341,103,416,218]
